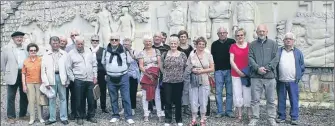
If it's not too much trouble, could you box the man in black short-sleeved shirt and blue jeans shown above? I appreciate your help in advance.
[211,27,236,118]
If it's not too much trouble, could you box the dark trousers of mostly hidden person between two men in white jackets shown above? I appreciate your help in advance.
[66,81,76,117]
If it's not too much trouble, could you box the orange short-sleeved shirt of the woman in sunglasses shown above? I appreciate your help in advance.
[22,57,42,84]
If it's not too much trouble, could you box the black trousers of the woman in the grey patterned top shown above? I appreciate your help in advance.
[163,82,184,123]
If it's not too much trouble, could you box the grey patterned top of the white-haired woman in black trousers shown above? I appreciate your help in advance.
[163,52,187,83]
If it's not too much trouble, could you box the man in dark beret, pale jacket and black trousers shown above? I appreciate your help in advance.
[1,31,28,124]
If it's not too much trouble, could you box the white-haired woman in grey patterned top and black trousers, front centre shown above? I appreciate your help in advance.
[163,37,187,126]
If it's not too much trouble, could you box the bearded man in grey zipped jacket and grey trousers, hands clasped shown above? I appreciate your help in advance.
[249,24,278,126]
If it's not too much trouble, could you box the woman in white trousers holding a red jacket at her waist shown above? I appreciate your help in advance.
[138,36,165,121]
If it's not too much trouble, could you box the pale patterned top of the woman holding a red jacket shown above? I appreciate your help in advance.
[138,49,161,69]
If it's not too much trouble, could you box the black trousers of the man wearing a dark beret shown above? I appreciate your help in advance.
[7,70,28,118]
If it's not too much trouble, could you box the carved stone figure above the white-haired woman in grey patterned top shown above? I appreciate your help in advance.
[168,1,187,35]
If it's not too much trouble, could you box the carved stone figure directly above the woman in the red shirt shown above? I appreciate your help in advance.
[233,1,258,42]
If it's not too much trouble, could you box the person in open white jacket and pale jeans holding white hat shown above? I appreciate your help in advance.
[41,36,69,125]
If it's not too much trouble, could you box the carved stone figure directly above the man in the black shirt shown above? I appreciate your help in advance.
[209,1,232,42]
